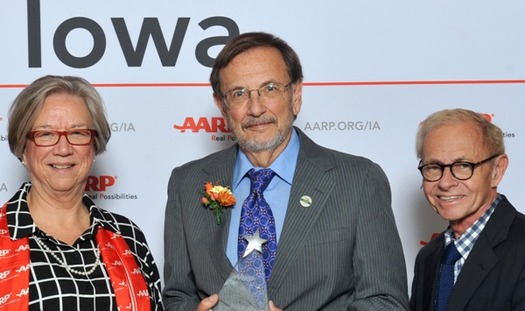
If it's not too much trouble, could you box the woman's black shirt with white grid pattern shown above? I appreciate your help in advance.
[6,183,163,311]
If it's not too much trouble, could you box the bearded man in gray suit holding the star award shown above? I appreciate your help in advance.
[163,33,408,311]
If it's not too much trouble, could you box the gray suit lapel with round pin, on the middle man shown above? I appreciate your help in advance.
[268,130,335,296]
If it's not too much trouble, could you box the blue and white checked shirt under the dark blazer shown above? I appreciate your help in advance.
[445,194,501,284]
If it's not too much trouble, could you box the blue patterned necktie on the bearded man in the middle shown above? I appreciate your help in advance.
[238,168,277,282]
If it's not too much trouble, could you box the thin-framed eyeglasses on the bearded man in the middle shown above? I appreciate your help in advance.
[222,82,292,108]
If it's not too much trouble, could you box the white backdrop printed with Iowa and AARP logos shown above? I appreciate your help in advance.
[0,0,525,294]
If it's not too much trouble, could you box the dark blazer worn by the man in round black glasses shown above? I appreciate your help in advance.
[410,197,525,311]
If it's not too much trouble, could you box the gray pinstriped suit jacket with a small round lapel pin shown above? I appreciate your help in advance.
[163,129,408,311]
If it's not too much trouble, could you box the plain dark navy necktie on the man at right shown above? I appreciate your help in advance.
[436,242,461,311]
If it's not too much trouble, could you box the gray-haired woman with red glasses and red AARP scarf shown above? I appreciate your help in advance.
[0,76,163,311]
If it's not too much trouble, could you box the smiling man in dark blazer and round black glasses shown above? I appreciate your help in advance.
[410,109,525,311]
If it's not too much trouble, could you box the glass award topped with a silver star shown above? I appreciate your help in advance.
[212,229,269,311]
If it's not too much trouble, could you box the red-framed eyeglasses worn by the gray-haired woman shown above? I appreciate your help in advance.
[27,129,97,147]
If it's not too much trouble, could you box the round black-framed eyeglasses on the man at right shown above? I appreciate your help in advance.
[417,154,500,182]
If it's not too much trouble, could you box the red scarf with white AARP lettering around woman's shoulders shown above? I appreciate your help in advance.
[0,204,150,311]
